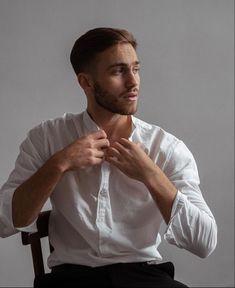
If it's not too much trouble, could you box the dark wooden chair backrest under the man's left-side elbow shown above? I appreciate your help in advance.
[21,210,53,276]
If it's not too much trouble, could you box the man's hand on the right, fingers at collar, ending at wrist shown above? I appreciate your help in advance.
[106,138,156,183]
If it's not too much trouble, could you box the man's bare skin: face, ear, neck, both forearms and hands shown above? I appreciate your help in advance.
[12,43,176,227]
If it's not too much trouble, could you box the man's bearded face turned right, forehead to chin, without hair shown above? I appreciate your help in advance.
[93,44,140,115]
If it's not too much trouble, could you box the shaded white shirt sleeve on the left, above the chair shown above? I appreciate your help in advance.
[0,126,45,237]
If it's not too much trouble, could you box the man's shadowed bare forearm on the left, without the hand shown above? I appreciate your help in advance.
[12,156,63,227]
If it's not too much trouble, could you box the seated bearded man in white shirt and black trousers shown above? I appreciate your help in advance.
[0,28,217,287]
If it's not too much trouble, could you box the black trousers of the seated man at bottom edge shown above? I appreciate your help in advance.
[34,262,187,288]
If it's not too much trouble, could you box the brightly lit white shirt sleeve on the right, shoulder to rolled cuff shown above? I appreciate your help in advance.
[164,141,217,258]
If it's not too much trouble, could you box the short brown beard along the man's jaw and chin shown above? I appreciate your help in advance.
[94,82,137,115]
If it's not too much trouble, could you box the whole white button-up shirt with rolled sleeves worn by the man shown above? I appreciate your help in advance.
[0,111,217,267]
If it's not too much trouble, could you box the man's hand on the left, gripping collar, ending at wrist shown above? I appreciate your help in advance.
[55,130,109,172]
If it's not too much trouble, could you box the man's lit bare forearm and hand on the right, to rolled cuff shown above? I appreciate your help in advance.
[106,138,177,223]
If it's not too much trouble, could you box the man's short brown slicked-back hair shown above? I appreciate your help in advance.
[70,27,137,75]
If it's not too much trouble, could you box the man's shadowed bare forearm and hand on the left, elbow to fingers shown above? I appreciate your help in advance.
[12,130,109,227]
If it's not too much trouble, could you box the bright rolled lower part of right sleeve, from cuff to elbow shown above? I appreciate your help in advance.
[164,192,217,258]
